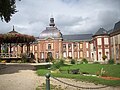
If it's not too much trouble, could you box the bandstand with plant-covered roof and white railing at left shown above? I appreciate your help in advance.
[0,26,35,60]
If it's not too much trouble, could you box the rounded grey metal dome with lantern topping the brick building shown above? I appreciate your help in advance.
[39,18,62,39]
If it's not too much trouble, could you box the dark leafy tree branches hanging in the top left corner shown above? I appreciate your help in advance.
[0,0,20,23]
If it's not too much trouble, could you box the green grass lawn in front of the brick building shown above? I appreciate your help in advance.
[37,64,120,86]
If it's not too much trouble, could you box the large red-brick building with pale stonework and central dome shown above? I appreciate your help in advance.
[12,18,120,62]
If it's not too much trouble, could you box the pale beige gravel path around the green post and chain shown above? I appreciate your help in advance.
[0,64,120,90]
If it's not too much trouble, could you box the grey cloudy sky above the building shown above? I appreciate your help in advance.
[0,0,120,37]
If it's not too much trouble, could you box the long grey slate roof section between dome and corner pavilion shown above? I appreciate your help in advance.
[63,34,93,41]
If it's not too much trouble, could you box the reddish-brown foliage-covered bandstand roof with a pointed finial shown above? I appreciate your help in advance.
[0,27,35,43]
